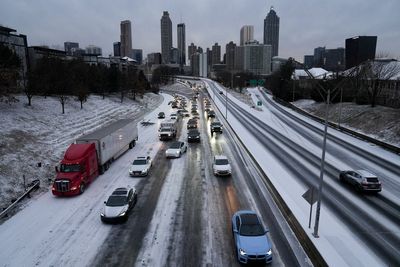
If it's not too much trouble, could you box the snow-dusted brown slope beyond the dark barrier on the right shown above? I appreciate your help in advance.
[293,99,400,147]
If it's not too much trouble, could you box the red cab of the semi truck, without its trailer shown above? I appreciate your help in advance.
[52,143,99,196]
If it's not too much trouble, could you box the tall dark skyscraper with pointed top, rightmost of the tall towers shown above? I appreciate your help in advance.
[264,7,279,57]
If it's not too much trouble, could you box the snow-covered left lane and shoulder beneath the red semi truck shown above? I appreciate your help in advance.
[0,92,172,266]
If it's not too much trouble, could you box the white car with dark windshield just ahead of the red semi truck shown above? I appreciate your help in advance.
[100,187,137,222]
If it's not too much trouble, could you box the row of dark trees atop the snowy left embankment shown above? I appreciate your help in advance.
[0,45,158,114]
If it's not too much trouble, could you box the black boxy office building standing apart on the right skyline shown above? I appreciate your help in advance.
[345,36,378,69]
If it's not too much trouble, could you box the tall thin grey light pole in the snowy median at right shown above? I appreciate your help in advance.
[313,89,331,238]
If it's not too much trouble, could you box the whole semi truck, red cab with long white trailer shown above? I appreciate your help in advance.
[52,119,138,196]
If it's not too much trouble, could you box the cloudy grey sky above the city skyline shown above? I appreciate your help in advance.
[0,0,400,61]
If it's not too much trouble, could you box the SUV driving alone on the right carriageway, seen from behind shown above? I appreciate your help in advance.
[339,170,382,193]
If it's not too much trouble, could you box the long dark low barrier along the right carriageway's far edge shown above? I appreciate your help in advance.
[274,97,400,154]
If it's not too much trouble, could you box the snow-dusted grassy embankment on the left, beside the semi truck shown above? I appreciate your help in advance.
[0,94,162,214]
